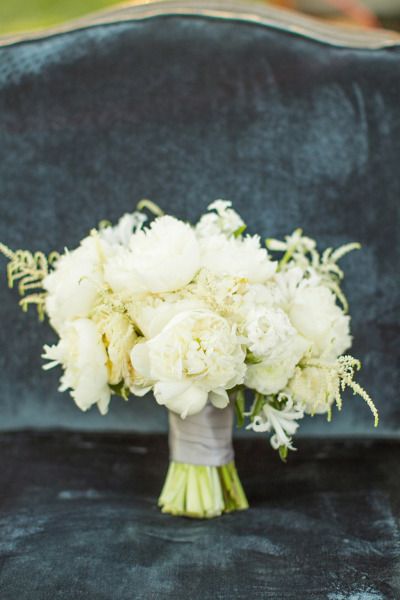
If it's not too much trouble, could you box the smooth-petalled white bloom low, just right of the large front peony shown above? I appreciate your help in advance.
[245,335,309,395]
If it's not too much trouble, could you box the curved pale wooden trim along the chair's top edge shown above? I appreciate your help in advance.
[0,0,400,50]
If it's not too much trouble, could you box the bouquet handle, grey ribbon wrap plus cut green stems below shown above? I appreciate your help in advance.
[158,403,249,519]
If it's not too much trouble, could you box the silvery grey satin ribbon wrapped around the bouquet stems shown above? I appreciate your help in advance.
[169,403,234,467]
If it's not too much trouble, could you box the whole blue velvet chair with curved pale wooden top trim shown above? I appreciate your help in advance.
[0,1,400,600]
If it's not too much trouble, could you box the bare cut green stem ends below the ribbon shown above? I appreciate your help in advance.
[158,461,249,519]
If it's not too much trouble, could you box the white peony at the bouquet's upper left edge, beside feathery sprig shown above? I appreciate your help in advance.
[43,236,107,333]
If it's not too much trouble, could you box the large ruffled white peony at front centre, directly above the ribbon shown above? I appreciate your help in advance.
[131,310,246,418]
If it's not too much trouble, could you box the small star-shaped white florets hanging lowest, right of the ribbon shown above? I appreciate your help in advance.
[246,392,304,457]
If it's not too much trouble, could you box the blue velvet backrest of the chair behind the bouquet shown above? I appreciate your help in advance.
[0,16,400,435]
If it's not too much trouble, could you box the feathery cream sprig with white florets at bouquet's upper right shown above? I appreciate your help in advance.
[265,229,361,312]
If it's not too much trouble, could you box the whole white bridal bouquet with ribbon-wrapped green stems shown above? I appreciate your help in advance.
[0,200,378,517]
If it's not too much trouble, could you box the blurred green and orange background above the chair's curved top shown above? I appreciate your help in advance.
[0,0,400,35]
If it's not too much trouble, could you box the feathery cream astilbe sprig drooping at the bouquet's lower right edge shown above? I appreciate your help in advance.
[307,354,379,427]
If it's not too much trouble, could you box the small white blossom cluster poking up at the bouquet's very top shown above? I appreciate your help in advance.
[195,200,245,237]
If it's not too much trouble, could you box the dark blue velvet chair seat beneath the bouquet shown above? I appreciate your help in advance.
[0,432,400,600]
